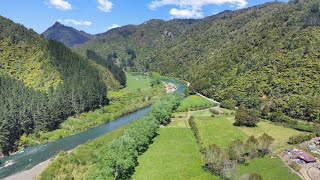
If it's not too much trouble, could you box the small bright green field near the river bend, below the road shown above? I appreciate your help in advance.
[177,95,215,112]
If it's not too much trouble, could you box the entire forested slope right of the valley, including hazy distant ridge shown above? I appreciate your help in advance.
[74,0,320,122]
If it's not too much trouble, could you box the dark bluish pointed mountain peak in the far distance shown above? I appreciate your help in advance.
[42,22,95,47]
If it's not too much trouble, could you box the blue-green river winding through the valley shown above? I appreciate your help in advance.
[0,80,185,179]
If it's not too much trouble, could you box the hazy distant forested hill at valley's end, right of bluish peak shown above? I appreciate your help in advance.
[73,19,196,67]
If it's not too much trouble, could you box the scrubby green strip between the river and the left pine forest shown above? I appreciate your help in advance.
[28,74,165,144]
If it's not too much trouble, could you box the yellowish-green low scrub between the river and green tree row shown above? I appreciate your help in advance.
[39,124,132,180]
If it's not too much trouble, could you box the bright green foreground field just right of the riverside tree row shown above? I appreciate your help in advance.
[132,125,218,180]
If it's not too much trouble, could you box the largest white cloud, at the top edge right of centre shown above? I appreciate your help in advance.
[149,0,248,18]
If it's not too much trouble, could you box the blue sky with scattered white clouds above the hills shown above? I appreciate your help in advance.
[0,0,288,34]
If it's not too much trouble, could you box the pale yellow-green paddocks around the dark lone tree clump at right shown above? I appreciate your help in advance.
[192,111,302,150]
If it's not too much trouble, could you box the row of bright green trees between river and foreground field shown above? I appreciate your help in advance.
[84,95,180,179]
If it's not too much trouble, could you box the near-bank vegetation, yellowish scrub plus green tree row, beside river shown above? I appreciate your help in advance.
[40,95,180,179]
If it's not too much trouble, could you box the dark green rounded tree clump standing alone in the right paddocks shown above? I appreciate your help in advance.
[234,105,260,127]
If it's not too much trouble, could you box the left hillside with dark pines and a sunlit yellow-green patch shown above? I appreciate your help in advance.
[0,16,123,155]
